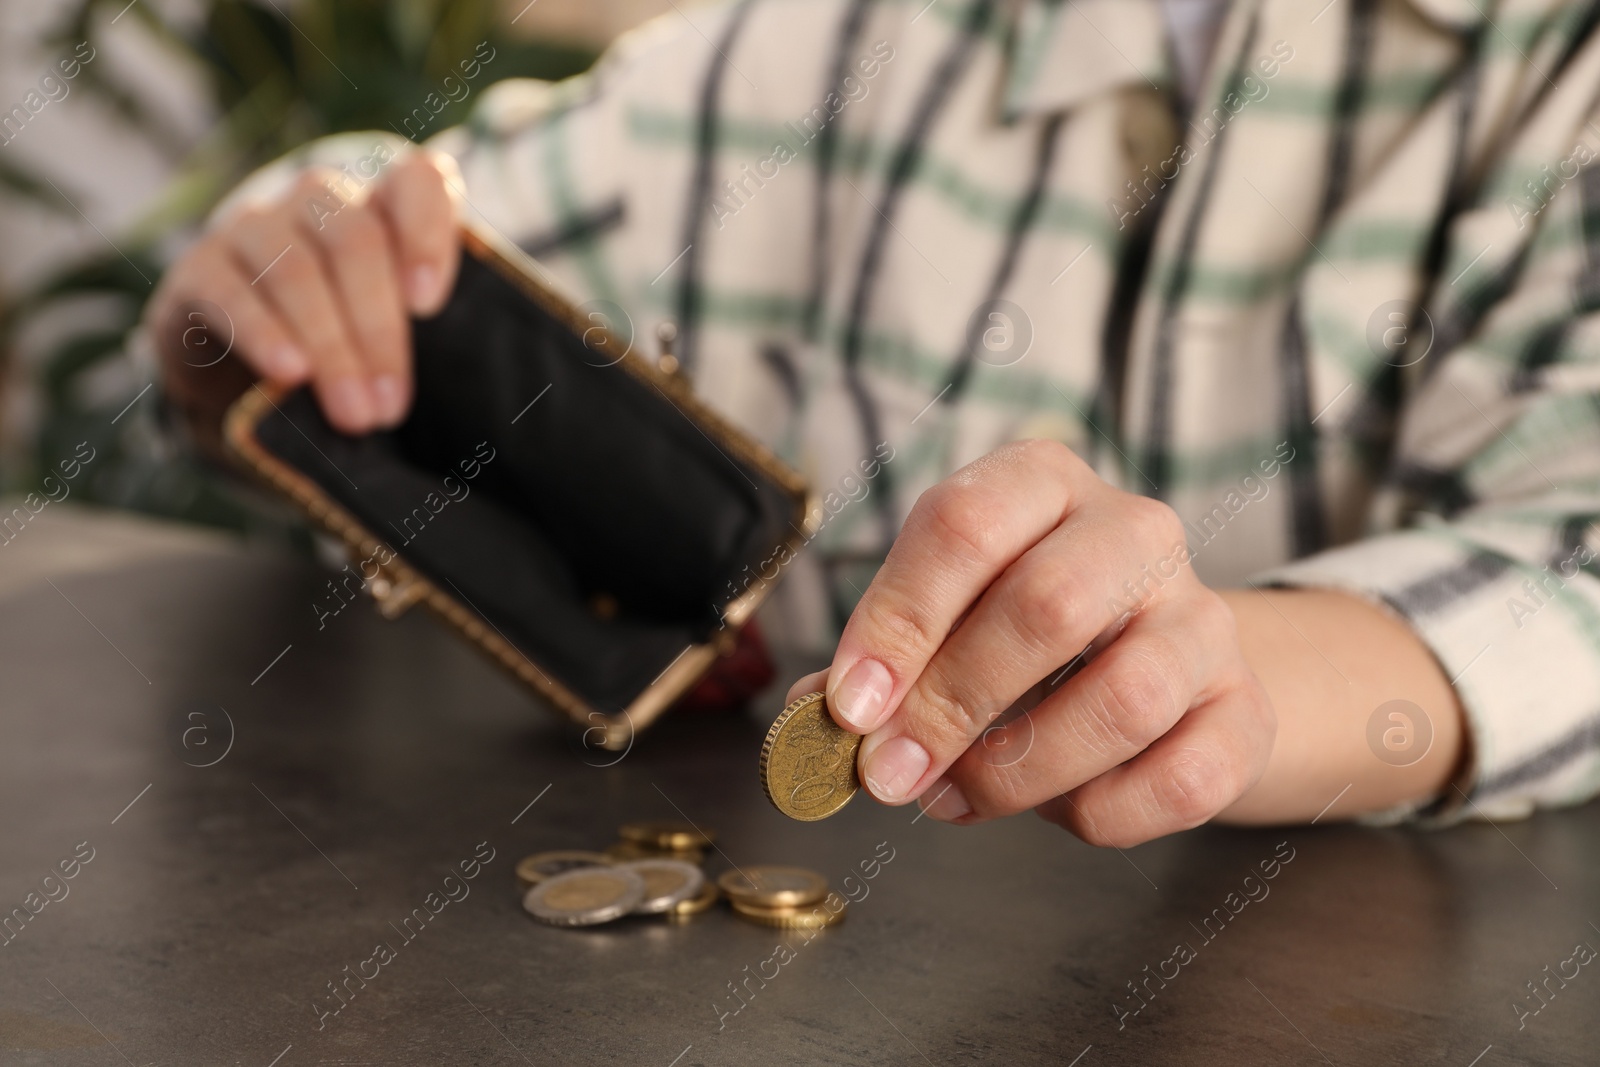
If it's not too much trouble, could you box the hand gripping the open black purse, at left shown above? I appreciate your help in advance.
[146,152,461,435]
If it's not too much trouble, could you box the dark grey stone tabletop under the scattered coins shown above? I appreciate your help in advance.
[0,509,1600,1067]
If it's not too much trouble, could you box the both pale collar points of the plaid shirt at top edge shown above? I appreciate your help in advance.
[1000,0,1488,122]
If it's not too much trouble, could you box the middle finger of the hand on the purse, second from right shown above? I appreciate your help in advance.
[302,170,411,426]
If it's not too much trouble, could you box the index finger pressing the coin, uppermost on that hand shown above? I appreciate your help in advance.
[827,442,1098,733]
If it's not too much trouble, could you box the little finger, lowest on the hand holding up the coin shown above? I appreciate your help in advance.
[1037,678,1277,848]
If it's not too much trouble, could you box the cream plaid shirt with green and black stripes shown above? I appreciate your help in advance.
[232,0,1600,817]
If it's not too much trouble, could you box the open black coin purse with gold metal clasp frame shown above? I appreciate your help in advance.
[224,220,808,750]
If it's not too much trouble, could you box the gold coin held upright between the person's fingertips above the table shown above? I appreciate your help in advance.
[762,693,861,822]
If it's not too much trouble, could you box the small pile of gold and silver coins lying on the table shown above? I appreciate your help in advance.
[517,822,845,929]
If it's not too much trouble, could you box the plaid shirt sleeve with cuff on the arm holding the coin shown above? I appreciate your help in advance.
[1256,117,1600,824]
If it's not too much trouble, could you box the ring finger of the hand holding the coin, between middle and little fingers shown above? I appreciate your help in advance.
[925,590,1253,822]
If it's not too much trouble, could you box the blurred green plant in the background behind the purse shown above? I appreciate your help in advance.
[0,0,595,533]
